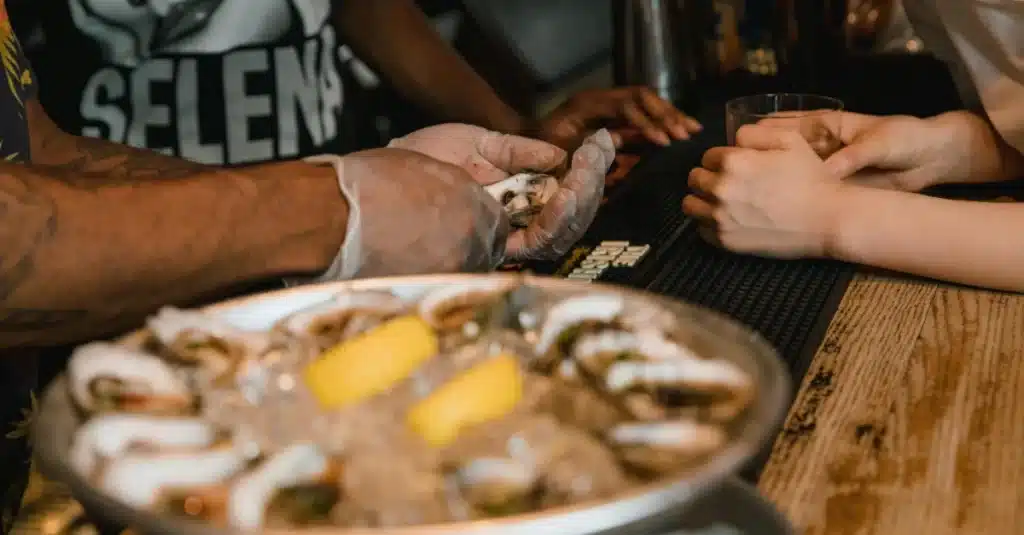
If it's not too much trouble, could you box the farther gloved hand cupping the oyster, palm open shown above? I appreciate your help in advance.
[388,124,615,261]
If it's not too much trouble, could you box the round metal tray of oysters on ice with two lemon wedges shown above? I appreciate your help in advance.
[34,275,790,535]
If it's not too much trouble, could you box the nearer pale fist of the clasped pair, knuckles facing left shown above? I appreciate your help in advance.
[683,125,846,257]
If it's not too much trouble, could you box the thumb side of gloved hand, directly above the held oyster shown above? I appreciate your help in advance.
[388,123,565,186]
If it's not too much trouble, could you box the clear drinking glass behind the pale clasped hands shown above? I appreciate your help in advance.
[725,93,843,158]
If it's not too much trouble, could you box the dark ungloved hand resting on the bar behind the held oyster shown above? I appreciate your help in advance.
[536,87,702,150]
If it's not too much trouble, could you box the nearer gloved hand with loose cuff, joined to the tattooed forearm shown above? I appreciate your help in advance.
[296,149,510,281]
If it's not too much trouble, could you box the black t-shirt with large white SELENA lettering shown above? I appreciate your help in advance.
[12,0,354,165]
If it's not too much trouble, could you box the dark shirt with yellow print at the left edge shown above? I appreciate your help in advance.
[0,0,37,533]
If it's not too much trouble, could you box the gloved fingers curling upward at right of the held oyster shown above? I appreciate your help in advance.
[506,129,615,260]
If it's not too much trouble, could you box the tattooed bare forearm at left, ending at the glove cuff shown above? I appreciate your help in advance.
[0,102,347,348]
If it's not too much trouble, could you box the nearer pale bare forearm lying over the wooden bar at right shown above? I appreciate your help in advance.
[830,187,1024,292]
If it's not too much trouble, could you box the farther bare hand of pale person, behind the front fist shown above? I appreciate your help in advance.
[760,112,997,192]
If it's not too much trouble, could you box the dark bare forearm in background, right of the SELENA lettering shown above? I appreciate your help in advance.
[335,0,526,133]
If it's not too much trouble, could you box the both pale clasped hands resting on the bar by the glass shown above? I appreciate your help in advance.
[683,112,994,257]
